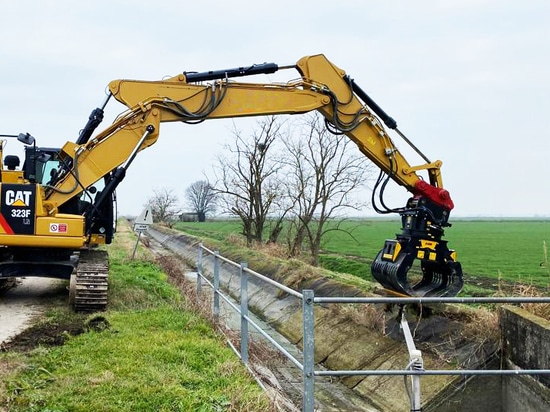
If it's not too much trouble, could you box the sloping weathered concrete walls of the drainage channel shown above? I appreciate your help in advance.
[149,228,550,412]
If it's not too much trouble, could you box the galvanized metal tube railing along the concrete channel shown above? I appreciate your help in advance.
[197,244,550,412]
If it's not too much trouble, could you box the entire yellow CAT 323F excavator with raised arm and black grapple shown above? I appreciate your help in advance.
[0,54,463,311]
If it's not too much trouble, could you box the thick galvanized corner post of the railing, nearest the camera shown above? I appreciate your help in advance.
[302,290,315,412]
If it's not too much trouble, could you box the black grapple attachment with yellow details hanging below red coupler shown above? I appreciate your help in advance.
[371,197,464,297]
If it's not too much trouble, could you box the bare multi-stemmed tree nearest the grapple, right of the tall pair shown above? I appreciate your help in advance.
[285,114,373,265]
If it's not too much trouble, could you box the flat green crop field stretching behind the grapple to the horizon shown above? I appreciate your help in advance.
[176,219,550,286]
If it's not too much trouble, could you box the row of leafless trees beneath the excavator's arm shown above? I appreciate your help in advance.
[146,113,374,265]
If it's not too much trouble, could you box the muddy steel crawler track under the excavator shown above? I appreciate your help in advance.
[69,250,109,312]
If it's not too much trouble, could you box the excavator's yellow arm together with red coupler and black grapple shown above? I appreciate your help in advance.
[47,55,463,296]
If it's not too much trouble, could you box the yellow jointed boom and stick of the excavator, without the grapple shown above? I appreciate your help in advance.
[48,55,452,208]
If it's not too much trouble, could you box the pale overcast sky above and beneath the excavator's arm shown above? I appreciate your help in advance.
[0,0,550,217]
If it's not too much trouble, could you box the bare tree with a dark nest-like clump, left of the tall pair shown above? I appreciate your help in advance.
[215,116,282,245]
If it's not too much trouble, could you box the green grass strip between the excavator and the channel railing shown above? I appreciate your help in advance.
[0,225,271,412]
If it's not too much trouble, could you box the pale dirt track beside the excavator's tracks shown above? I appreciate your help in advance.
[0,278,68,344]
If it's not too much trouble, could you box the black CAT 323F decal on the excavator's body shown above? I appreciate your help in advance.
[0,183,36,235]
